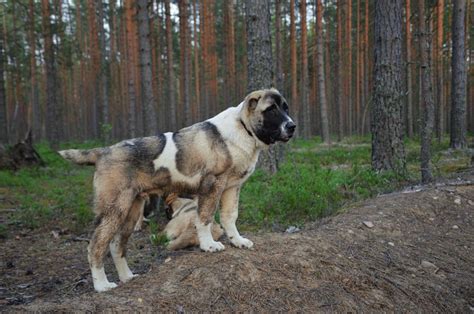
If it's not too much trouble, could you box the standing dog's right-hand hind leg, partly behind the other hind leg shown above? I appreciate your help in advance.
[110,197,145,282]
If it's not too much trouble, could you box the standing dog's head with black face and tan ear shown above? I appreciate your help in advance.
[244,88,296,145]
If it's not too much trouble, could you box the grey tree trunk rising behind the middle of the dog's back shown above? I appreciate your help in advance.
[137,0,158,135]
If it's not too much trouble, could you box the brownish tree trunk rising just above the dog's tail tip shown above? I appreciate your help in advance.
[41,0,61,149]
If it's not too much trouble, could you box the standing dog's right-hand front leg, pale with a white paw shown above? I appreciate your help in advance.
[221,187,253,249]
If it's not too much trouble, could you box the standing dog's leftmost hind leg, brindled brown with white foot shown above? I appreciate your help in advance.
[88,190,134,292]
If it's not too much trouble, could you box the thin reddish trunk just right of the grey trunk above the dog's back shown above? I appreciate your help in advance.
[165,0,178,131]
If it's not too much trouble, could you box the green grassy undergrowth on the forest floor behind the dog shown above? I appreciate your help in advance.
[0,137,470,236]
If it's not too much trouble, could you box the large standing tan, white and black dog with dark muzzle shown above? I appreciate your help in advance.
[59,89,296,292]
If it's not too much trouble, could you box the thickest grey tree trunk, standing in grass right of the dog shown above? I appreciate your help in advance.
[371,0,405,173]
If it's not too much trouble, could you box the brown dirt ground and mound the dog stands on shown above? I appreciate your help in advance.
[0,175,474,313]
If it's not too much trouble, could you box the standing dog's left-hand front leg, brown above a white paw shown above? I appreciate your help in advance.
[195,176,227,252]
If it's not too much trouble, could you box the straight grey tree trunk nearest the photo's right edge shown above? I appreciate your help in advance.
[450,0,467,149]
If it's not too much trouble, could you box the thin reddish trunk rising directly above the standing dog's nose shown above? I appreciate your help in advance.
[288,0,301,133]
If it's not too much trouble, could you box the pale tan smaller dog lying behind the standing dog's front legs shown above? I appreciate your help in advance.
[164,193,224,250]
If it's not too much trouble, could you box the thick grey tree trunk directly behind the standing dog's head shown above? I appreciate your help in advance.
[245,0,282,173]
